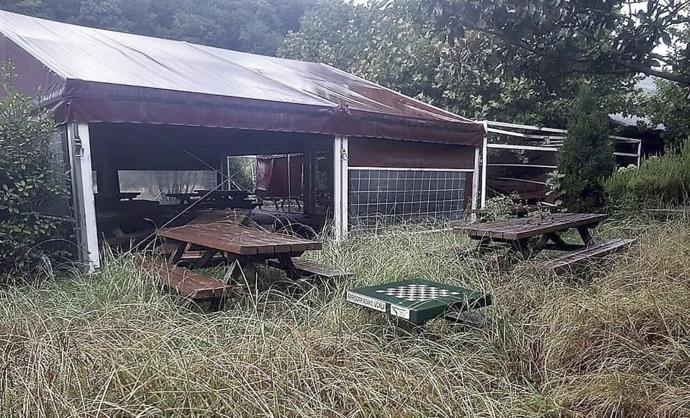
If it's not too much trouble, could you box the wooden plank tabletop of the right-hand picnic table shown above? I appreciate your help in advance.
[456,213,608,240]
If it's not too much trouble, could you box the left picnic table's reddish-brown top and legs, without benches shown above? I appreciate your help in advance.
[156,222,322,279]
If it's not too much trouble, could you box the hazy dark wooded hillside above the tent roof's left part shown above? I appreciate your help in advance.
[0,0,318,54]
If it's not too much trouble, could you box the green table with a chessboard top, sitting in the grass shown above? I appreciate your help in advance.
[347,279,491,325]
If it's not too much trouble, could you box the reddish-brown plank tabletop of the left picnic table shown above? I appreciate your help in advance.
[156,222,322,255]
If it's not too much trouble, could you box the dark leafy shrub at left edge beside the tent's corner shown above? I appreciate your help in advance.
[0,65,66,271]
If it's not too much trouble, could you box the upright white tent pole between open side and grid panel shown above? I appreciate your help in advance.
[333,135,350,241]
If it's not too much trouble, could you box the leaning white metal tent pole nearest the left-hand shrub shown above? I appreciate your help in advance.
[67,123,101,272]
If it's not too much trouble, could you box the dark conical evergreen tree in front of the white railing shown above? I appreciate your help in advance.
[556,84,615,212]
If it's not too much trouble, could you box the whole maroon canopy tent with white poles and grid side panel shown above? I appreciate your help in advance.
[0,11,485,268]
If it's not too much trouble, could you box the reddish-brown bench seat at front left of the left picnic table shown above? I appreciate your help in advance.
[149,261,231,311]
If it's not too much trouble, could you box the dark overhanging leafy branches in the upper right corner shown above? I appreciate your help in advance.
[424,0,690,85]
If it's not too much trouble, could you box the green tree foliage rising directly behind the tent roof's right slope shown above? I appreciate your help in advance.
[279,0,634,126]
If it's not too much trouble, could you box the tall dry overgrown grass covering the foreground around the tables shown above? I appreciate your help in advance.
[0,214,690,417]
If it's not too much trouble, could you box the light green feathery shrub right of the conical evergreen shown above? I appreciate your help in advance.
[605,140,690,207]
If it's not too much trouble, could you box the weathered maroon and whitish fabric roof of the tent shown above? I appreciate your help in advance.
[0,12,484,145]
